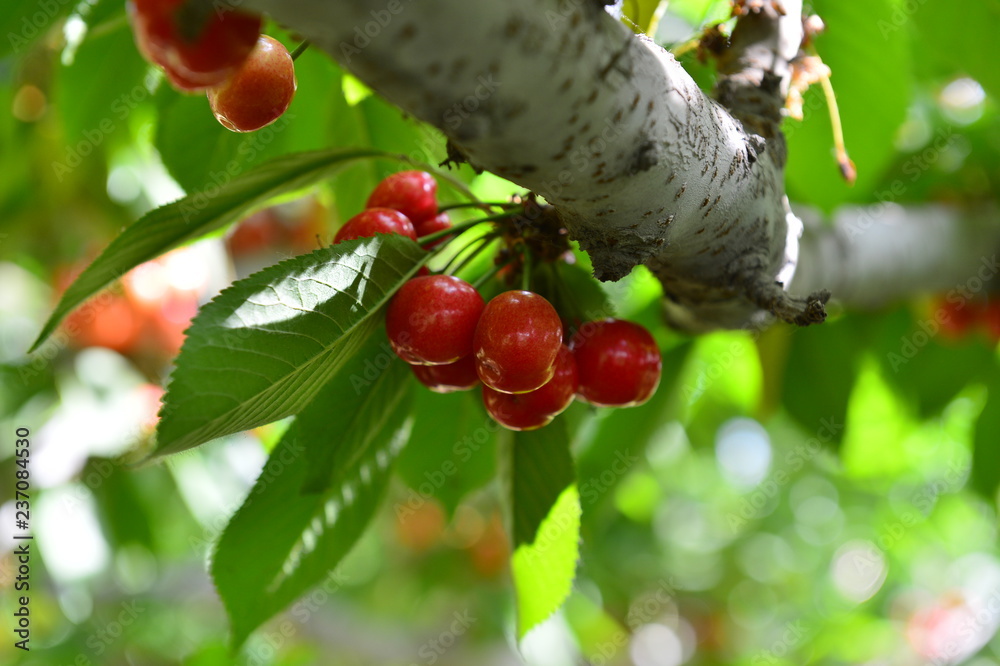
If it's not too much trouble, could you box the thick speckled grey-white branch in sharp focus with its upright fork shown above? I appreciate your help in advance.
[225,0,1000,331]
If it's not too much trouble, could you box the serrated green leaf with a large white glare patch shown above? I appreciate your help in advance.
[156,234,426,455]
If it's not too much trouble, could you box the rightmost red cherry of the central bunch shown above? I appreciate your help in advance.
[570,319,663,407]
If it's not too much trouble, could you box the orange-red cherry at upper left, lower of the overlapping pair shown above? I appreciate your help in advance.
[208,35,296,132]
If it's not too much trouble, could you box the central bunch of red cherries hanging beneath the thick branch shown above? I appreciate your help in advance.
[334,171,662,430]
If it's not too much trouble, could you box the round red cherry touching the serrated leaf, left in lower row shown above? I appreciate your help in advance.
[385,275,483,365]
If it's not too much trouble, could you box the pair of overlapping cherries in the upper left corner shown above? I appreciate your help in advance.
[128,0,296,132]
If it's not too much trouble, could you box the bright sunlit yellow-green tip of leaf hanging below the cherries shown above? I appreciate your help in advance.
[511,485,580,639]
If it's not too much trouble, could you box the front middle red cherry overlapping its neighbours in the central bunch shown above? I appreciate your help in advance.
[473,291,562,393]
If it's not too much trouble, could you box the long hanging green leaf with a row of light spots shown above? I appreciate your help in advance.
[212,352,412,648]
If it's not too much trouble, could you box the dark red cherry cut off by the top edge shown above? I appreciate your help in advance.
[128,0,263,91]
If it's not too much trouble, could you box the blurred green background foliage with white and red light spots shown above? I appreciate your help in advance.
[0,0,1000,666]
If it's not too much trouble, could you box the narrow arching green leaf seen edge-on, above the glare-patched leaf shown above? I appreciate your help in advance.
[30,149,387,351]
